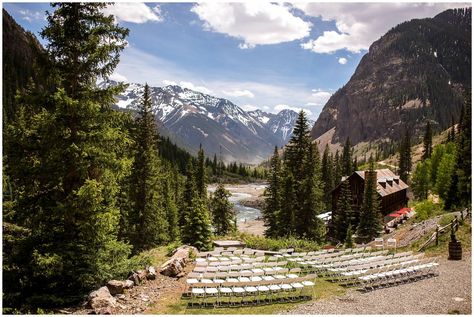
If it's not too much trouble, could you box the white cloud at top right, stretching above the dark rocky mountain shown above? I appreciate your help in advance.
[295,2,464,53]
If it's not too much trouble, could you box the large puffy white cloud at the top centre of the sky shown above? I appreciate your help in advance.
[191,1,311,49]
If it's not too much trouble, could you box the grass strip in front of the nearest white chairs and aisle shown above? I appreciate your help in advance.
[152,278,346,315]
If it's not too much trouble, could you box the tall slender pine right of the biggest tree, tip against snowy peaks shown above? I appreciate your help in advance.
[129,84,168,251]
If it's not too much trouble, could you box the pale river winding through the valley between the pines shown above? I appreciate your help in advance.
[207,183,266,223]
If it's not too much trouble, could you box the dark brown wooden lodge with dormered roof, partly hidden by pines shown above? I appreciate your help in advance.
[332,169,408,222]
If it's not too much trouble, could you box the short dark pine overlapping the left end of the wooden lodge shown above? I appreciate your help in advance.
[333,181,353,241]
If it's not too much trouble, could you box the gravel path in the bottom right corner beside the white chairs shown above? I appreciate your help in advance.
[285,251,472,315]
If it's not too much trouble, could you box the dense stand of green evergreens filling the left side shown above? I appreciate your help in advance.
[3,3,235,308]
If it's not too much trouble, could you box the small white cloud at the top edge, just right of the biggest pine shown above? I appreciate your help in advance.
[103,2,163,23]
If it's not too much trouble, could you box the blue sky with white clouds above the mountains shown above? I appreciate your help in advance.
[4,2,467,119]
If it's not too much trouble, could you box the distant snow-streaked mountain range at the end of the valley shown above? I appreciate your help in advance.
[110,82,314,163]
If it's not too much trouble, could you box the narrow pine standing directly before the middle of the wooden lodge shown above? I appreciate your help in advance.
[357,157,382,241]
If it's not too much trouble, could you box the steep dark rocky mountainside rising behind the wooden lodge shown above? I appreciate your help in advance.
[311,8,471,144]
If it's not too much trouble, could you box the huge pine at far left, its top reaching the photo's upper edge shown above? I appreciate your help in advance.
[5,3,131,305]
